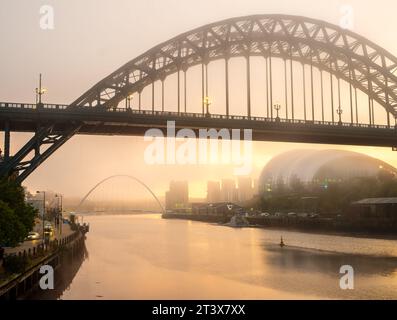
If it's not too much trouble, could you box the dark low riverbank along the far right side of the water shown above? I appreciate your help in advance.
[162,213,397,239]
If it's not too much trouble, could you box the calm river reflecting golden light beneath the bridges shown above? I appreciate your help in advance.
[44,214,397,299]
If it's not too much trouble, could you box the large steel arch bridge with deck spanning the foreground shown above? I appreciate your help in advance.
[0,15,397,181]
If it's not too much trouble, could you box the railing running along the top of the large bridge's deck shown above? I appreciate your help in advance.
[0,102,396,130]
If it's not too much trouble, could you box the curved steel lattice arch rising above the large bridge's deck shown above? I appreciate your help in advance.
[72,15,397,117]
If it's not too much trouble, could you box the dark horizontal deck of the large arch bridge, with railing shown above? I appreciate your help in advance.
[0,103,397,147]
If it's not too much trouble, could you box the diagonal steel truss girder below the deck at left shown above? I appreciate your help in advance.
[0,124,81,183]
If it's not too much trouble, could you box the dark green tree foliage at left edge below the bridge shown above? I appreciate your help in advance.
[0,179,37,247]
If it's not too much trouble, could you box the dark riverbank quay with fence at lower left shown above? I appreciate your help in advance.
[0,225,89,300]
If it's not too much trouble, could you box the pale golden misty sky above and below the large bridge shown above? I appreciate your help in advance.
[0,0,397,200]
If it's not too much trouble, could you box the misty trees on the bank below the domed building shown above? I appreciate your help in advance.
[258,170,397,214]
